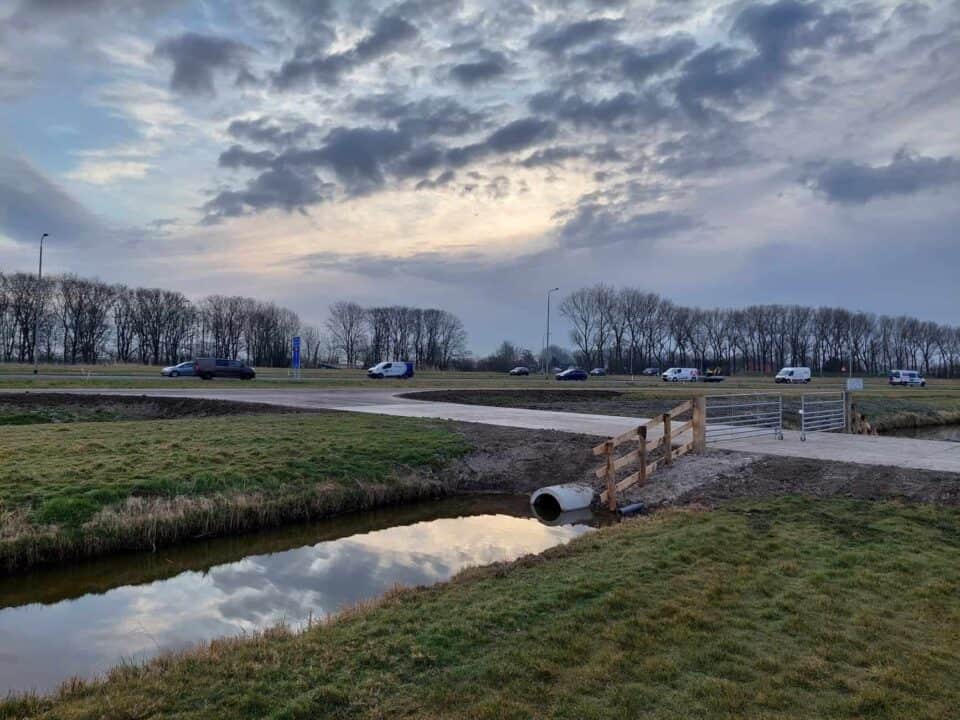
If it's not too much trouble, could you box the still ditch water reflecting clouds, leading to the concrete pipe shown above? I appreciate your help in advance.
[0,495,598,696]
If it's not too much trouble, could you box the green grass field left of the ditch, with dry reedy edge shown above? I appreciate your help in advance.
[0,413,469,571]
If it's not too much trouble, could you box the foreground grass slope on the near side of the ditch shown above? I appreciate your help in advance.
[9,499,960,720]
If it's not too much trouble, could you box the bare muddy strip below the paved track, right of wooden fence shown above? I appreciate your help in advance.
[621,450,960,508]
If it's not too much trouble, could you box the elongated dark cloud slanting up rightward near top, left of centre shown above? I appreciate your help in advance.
[272,14,420,90]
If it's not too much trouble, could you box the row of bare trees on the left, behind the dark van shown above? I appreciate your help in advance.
[0,273,466,368]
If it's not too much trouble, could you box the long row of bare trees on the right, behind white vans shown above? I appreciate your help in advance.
[546,284,960,376]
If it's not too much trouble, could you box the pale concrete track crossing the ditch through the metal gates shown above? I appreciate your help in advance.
[9,385,960,473]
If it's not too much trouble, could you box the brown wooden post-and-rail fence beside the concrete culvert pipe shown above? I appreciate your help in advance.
[593,396,707,510]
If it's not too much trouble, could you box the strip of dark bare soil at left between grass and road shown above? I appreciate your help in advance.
[0,392,310,425]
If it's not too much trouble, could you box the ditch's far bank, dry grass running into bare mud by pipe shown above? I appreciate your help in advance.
[0,423,596,574]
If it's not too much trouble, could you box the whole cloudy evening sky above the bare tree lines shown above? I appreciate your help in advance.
[0,0,960,354]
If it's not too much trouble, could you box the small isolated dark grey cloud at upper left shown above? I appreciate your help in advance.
[154,32,251,96]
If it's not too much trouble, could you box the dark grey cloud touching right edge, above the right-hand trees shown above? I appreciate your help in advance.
[803,150,960,205]
